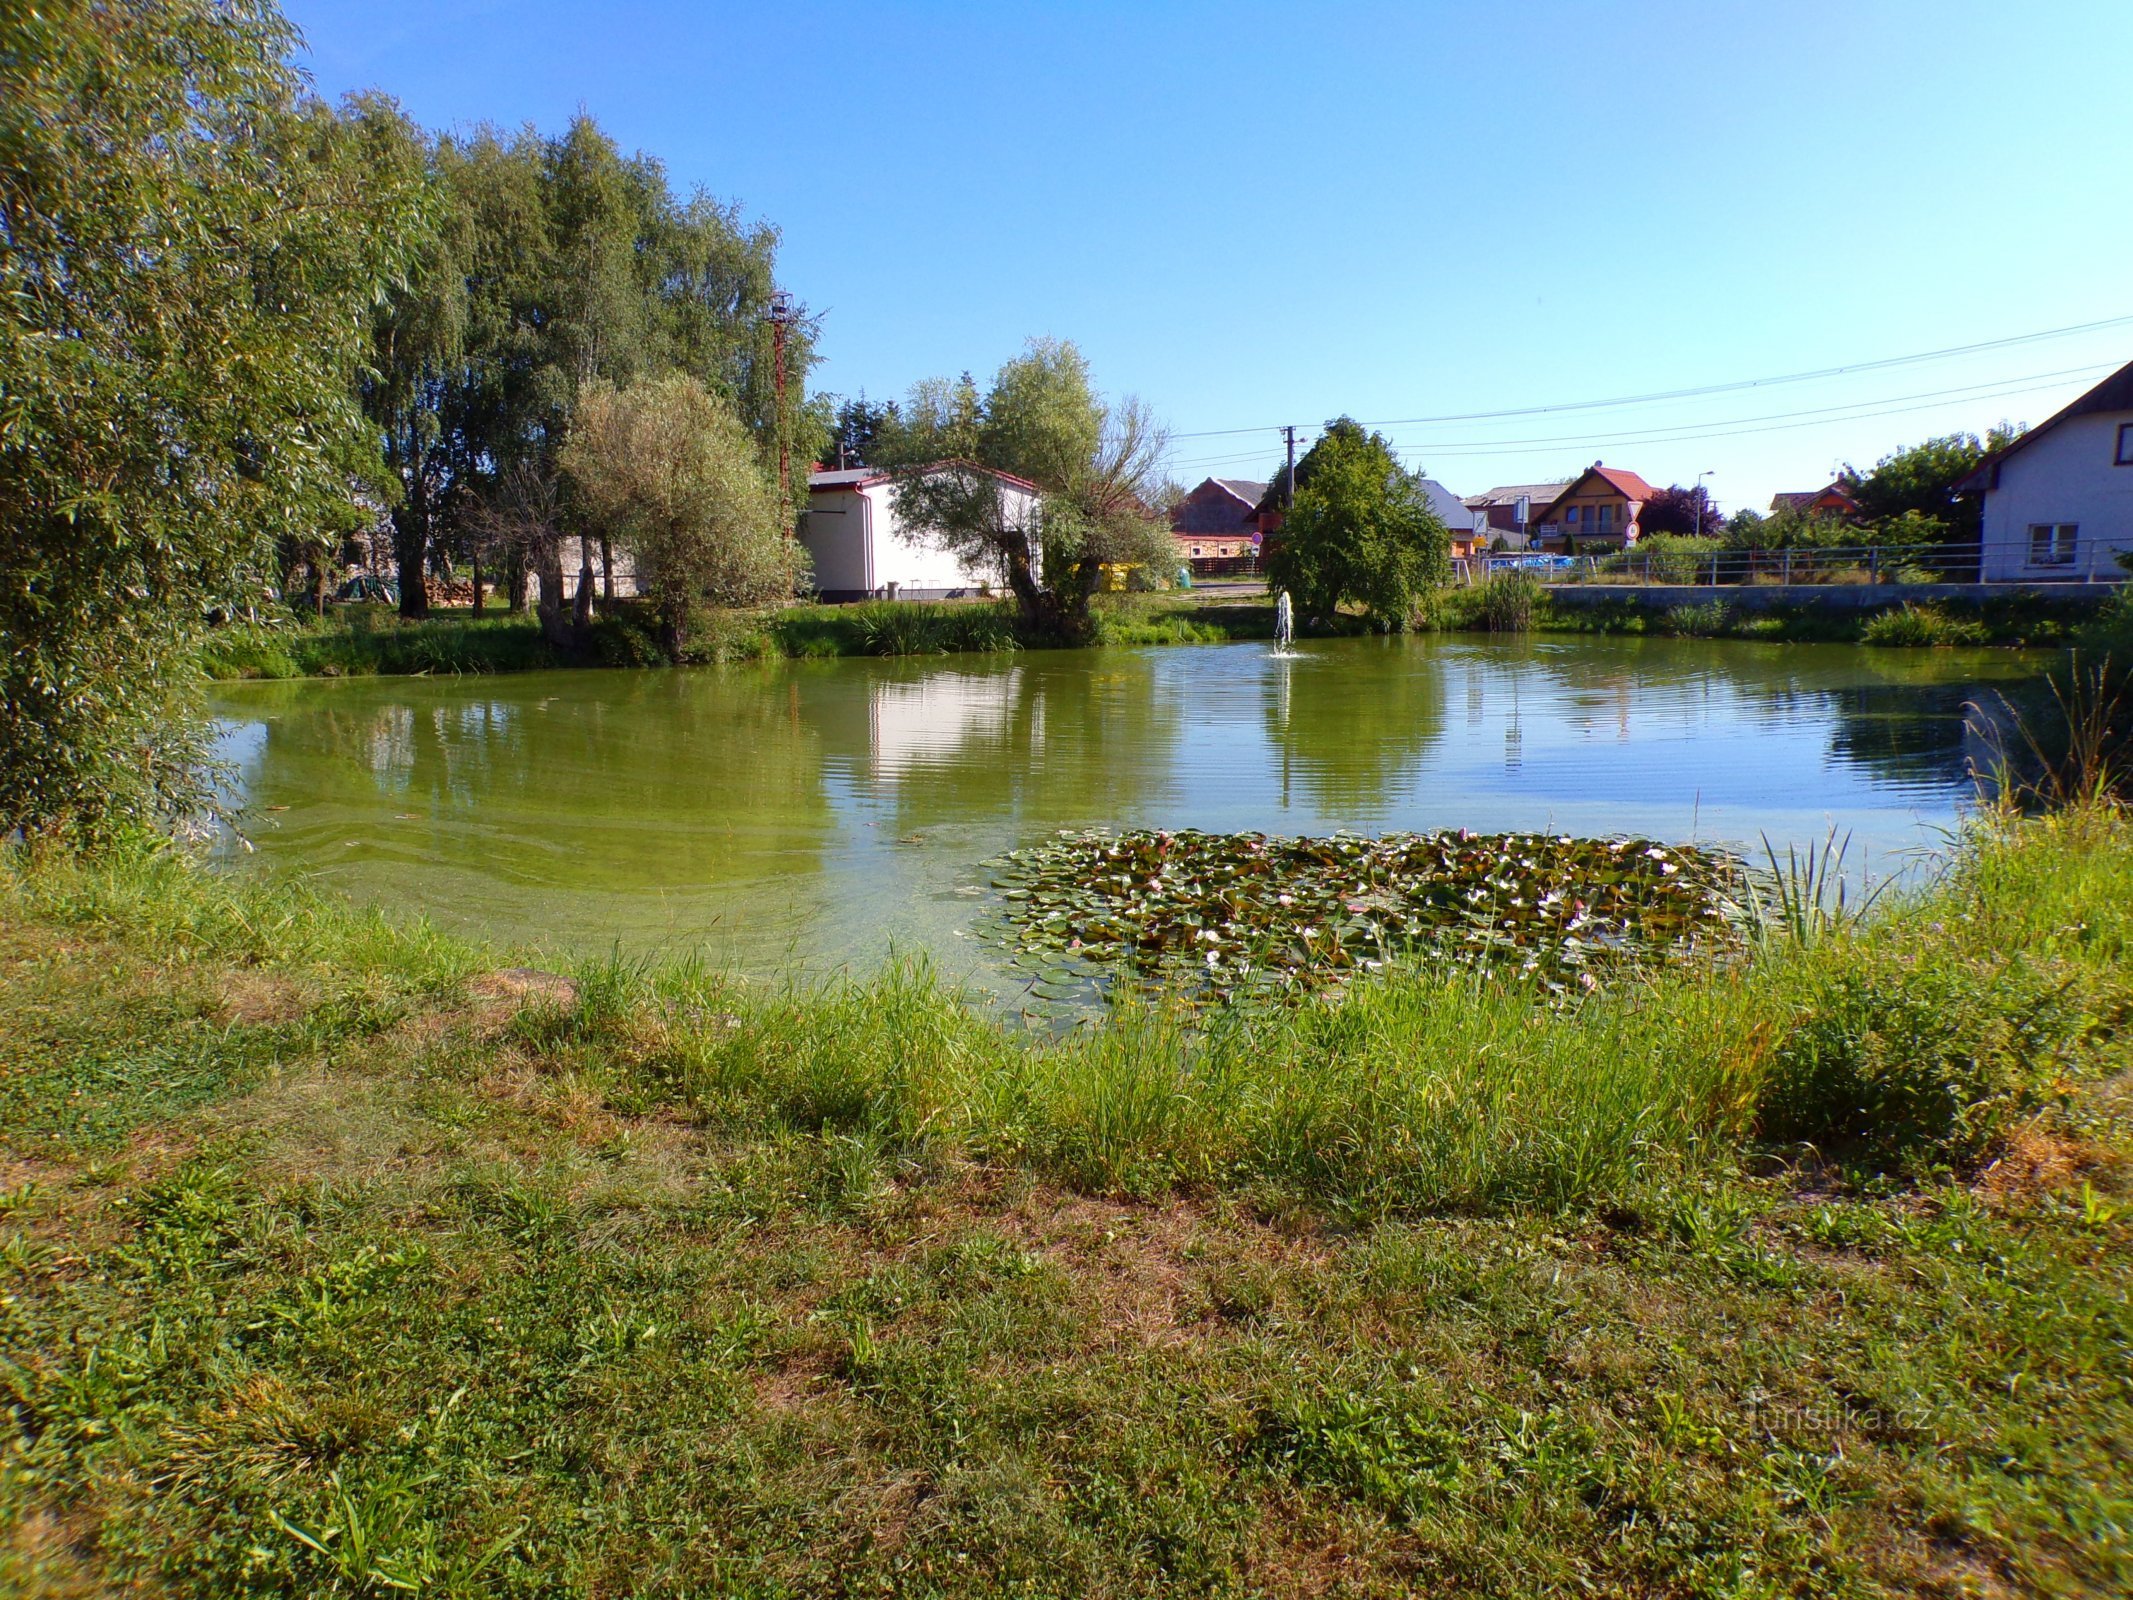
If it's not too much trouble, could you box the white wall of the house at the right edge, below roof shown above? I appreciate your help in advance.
[1984,412,2133,580]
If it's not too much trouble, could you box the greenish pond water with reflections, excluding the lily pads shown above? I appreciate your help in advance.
[215,636,2037,992]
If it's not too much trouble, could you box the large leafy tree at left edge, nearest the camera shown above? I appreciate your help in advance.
[0,0,420,836]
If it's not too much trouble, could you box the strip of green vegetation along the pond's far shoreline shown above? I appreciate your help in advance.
[201,580,2133,681]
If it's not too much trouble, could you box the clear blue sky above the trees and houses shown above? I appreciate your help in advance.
[288,0,2133,506]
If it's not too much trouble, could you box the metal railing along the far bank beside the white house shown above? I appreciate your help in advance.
[1465,542,2120,587]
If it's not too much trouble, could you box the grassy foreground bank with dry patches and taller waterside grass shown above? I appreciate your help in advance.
[0,813,2133,1596]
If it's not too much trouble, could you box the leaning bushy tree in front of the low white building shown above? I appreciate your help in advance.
[875,339,1171,638]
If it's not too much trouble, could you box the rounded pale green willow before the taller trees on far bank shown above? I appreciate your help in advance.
[561,373,804,657]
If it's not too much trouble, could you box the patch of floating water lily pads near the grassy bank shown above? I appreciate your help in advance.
[988,830,1741,1001]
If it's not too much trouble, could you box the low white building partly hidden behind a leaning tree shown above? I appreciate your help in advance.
[800,463,1039,599]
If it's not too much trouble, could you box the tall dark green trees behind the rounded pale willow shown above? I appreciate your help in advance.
[356,114,825,614]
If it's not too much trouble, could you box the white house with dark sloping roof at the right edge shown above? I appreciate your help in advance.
[1960,365,2133,582]
